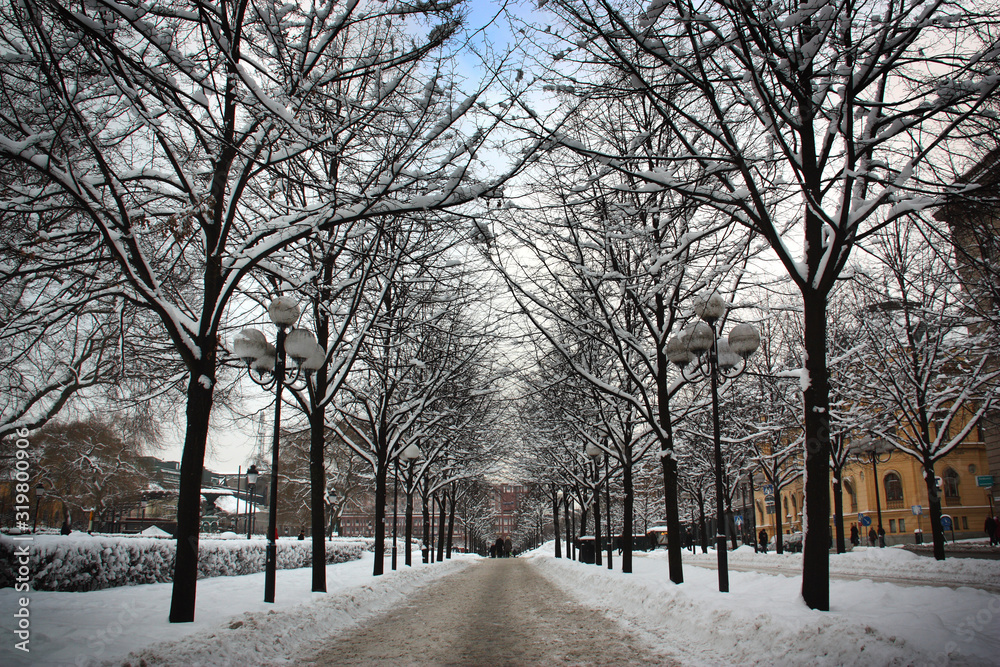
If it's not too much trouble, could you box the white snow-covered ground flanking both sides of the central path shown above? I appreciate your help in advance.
[0,544,1000,666]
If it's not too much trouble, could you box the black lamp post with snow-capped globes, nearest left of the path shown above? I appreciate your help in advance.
[233,296,326,602]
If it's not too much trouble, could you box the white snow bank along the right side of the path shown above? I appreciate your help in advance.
[530,544,1000,667]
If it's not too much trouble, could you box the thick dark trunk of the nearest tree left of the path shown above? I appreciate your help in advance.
[169,360,216,623]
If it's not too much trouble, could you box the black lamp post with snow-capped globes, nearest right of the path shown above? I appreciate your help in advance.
[667,293,760,593]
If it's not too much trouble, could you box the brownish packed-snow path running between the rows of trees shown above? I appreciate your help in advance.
[299,558,676,667]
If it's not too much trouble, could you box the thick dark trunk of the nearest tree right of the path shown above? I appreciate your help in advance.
[802,290,830,611]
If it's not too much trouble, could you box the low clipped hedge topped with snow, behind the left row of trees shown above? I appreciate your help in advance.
[0,533,368,592]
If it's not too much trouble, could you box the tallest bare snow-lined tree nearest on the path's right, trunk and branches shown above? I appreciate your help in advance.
[531,0,1000,610]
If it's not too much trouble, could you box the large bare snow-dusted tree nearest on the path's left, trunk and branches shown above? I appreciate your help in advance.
[0,0,524,622]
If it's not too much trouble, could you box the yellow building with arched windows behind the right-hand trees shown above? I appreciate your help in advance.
[754,436,992,544]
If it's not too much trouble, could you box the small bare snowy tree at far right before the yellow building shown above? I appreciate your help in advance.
[855,220,1000,560]
